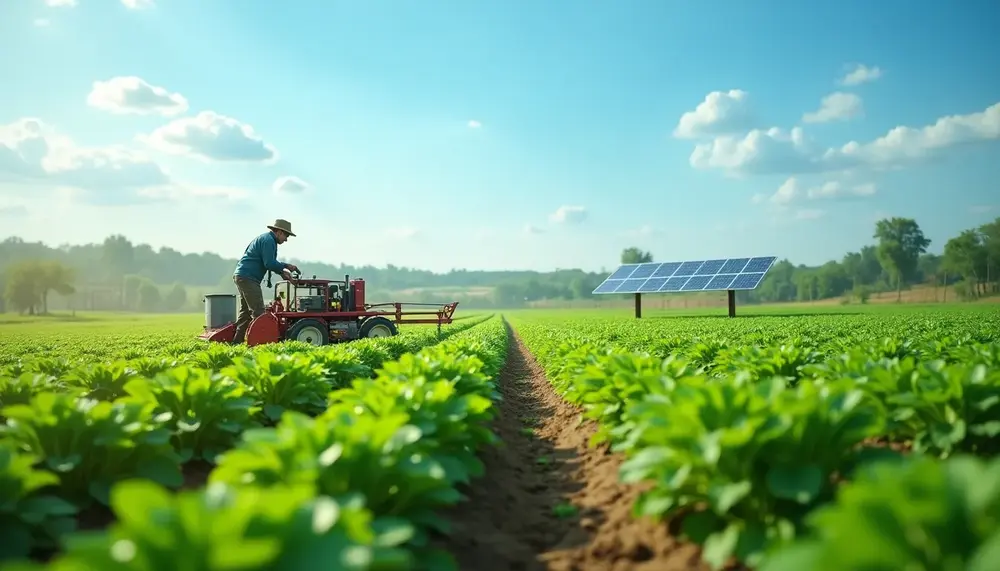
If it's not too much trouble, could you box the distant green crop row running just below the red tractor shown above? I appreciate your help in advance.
[0,316,490,421]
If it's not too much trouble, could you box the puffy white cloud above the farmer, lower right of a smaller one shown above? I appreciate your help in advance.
[138,111,278,162]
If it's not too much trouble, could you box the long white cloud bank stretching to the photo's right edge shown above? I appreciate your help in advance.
[689,103,1000,174]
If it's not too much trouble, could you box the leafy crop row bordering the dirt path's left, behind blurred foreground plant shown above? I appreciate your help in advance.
[210,325,506,566]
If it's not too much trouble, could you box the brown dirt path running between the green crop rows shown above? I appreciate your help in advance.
[441,325,707,571]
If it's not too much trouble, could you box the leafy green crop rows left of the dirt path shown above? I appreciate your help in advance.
[0,319,506,571]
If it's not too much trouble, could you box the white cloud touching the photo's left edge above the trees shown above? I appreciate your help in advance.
[0,118,170,196]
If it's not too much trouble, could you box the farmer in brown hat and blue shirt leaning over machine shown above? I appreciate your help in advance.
[233,218,299,344]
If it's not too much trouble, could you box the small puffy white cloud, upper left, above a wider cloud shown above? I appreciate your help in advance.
[87,76,188,116]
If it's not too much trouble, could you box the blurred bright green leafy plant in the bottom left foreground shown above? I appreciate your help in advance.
[20,481,413,571]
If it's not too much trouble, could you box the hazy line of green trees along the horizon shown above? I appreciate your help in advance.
[0,217,1000,312]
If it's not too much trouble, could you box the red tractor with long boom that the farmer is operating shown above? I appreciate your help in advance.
[198,273,458,346]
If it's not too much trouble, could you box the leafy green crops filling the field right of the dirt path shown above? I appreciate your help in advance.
[512,318,1000,571]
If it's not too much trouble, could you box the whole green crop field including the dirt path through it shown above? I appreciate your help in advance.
[0,304,1000,571]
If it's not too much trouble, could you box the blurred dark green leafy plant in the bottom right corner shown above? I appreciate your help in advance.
[759,455,1000,571]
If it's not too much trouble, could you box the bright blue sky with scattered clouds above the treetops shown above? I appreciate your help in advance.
[0,0,1000,271]
